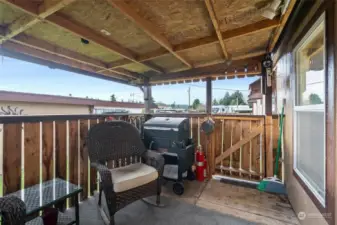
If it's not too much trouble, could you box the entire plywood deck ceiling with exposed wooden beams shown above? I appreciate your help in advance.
[0,0,293,82]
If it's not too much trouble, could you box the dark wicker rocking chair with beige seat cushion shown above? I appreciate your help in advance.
[87,121,164,225]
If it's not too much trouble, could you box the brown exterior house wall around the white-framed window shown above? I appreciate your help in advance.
[274,1,337,225]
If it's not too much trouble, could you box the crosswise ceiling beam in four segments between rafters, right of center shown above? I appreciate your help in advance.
[100,19,280,69]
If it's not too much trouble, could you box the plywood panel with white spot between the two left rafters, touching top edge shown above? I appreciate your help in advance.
[60,0,161,55]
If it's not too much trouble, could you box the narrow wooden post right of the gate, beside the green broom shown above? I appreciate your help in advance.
[262,62,274,177]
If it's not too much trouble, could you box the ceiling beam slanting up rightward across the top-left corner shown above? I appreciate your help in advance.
[0,0,75,44]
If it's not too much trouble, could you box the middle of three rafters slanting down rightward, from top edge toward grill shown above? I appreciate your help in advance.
[108,0,192,68]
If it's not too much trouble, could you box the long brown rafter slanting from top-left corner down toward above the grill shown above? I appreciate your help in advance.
[0,0,163,73]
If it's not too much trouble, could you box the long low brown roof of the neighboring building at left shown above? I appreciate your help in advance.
[0,91,144,108]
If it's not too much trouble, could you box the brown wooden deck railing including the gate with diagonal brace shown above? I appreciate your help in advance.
[0,114,278,204]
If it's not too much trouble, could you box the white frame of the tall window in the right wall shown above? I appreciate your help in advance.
[292,13,326,207]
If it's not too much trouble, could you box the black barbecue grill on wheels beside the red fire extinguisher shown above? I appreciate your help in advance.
[144,117,194,195]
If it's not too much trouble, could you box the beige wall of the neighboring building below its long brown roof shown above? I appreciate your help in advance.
[0,101,90,116]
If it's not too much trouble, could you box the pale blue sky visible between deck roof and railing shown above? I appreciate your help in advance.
[0,56,258,104]
